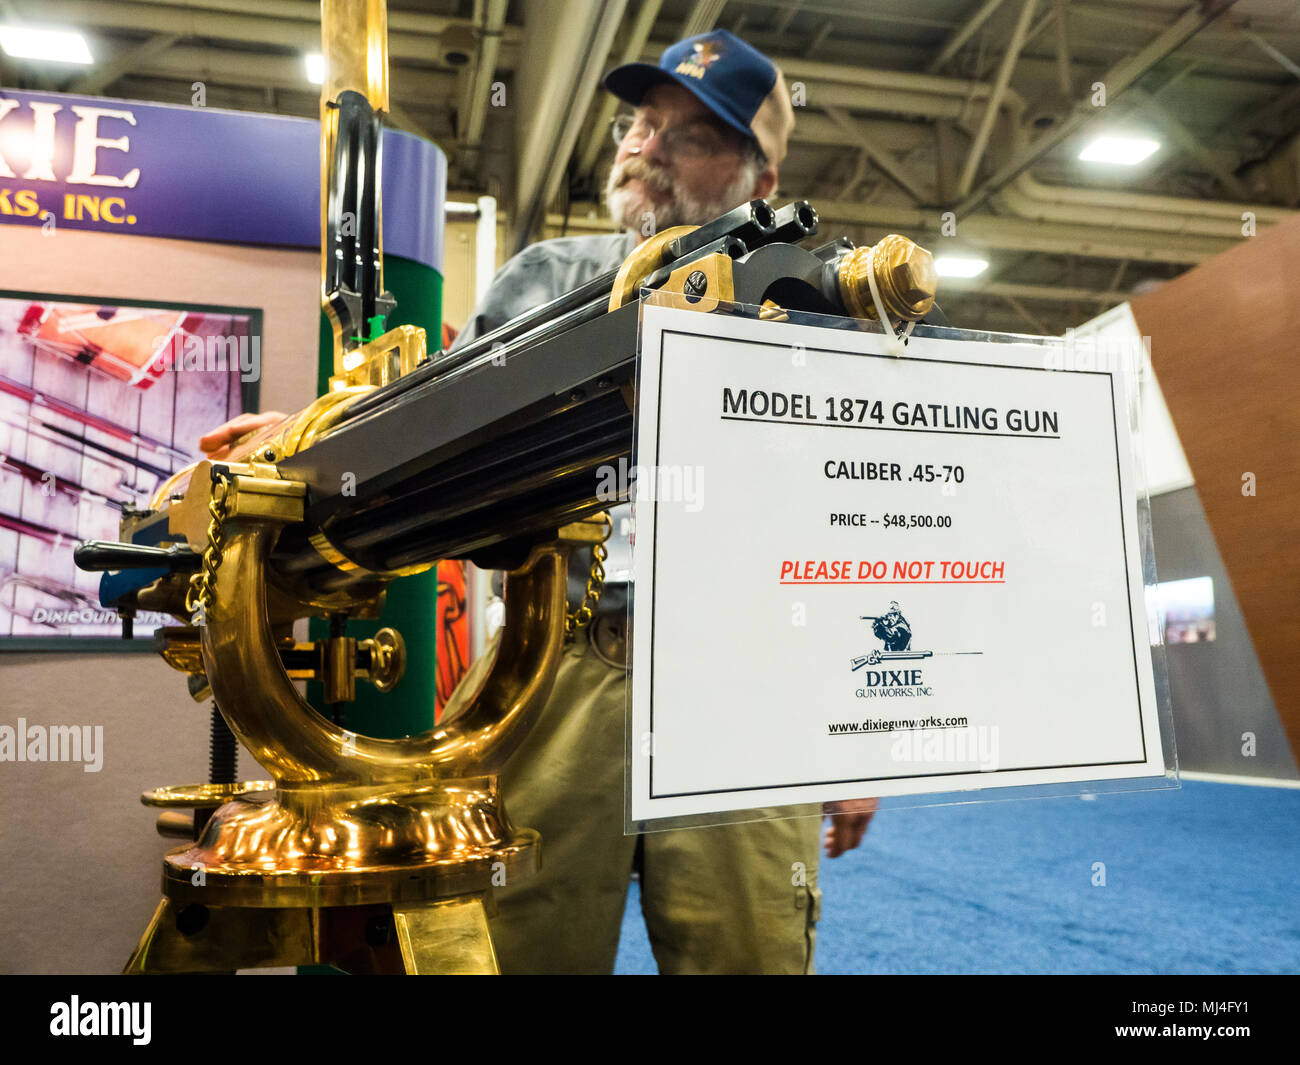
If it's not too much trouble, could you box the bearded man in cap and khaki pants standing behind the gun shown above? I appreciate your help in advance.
[203,30,874,973]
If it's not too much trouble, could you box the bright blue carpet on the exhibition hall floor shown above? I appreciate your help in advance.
[615,782,1300,974]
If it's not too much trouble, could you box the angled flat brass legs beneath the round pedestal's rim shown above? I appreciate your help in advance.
[122,895,501,975]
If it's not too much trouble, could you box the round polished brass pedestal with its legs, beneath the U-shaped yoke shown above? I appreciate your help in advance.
[125,778,541,974]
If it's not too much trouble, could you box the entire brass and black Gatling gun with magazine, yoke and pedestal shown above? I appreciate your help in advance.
[78,0,939,973]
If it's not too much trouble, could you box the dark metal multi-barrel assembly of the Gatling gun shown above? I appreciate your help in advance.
[109,200,935,600]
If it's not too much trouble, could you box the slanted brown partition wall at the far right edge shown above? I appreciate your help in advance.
[1132,217,1300,759]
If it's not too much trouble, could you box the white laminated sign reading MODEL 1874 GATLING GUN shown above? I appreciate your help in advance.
[629,304,1165,822]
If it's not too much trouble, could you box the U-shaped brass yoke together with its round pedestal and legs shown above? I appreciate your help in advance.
[118,467,607,973]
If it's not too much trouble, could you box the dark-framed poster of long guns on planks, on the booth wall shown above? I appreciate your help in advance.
[0,291,263,650]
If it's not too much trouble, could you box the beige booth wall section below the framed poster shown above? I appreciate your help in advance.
[0,653,246,973]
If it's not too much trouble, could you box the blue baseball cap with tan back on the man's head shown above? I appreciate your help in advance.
[605,30,794,163]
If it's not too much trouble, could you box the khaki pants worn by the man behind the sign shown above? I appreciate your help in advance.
[491,632,820,974]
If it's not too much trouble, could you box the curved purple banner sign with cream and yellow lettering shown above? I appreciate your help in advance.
[0,88,447,272]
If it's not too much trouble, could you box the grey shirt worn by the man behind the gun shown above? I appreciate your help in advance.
[451,233,637,612]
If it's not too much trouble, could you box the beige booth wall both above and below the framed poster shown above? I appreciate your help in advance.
[0,225,320,973]
